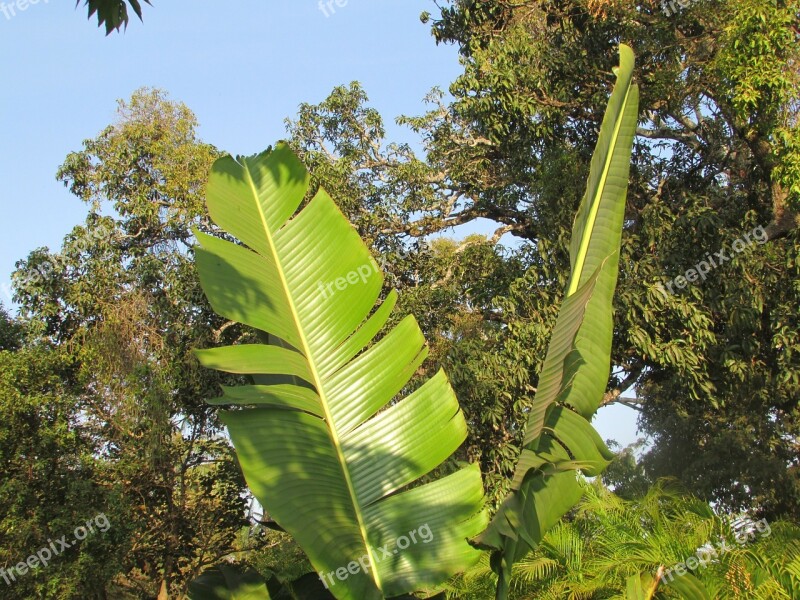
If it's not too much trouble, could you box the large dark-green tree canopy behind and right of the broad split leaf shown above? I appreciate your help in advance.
[289,0,800,517]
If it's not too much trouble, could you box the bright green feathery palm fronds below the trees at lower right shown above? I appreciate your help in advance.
[448,481,800,600]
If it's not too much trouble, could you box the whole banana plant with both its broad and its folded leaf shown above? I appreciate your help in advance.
[195,46,638,600]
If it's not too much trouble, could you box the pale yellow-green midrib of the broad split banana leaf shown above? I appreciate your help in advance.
[242,161,383,590]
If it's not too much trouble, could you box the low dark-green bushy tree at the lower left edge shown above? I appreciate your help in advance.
[0,346,122,599]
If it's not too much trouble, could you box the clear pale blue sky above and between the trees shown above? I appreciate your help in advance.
[0,0,636,443]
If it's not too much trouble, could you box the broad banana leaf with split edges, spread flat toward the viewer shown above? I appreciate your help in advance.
[196,144,488,600]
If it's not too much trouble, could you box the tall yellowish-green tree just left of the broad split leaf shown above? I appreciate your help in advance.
[14,90,256,599]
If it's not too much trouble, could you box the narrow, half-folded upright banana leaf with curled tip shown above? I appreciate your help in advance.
[476,45,638,598]
